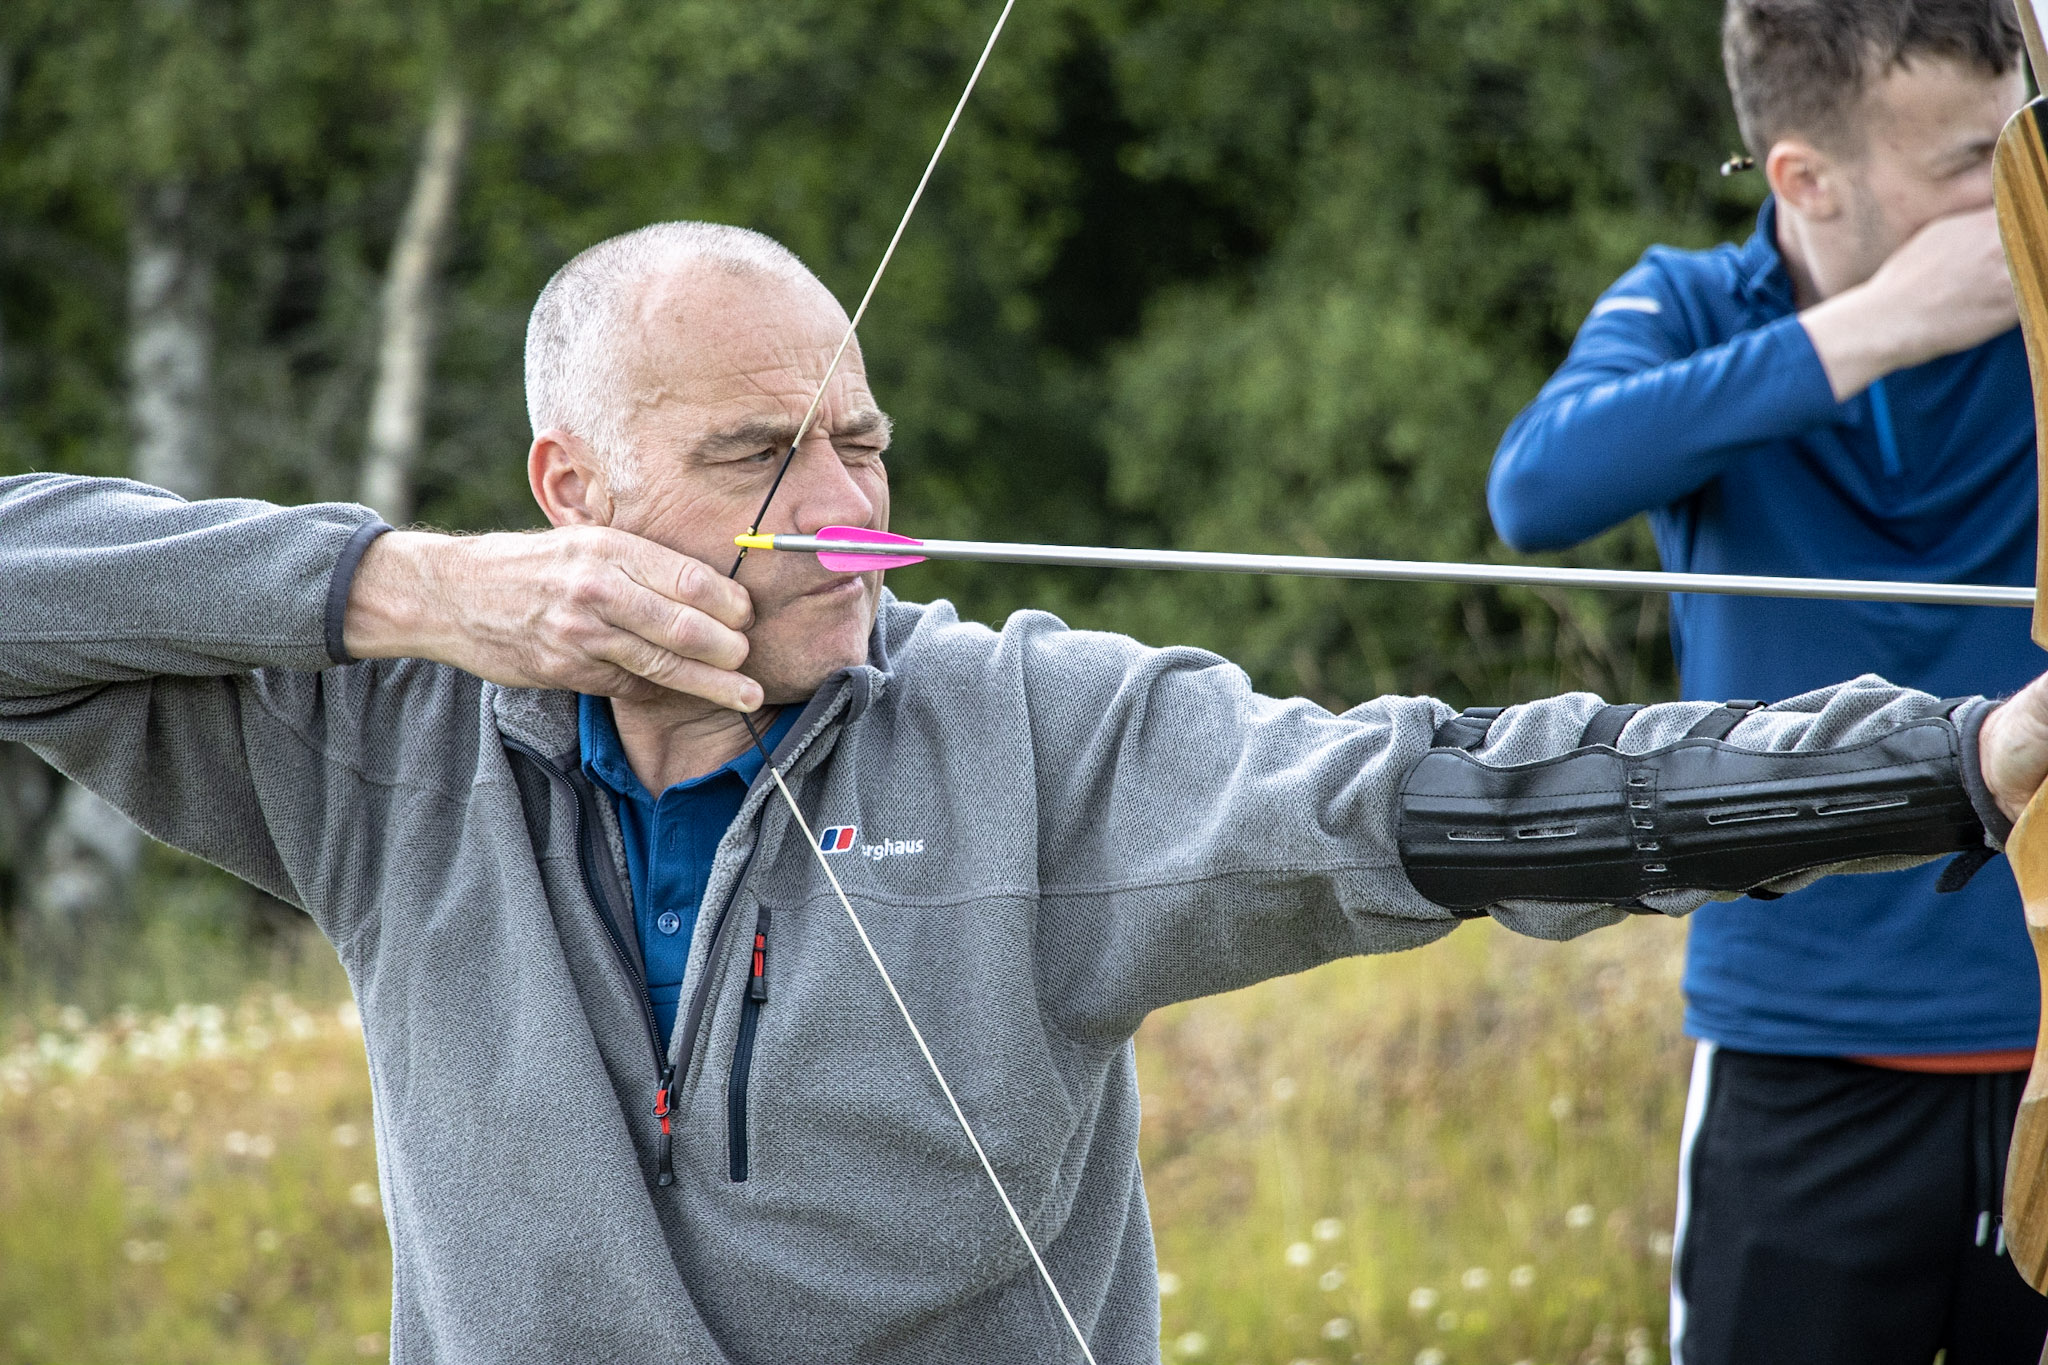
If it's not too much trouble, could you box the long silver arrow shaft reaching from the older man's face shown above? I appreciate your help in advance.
[772,536,2034,608]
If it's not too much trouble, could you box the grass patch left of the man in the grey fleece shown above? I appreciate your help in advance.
[0,995,391,1363]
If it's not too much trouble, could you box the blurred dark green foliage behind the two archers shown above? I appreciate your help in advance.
[0,0,1753,704]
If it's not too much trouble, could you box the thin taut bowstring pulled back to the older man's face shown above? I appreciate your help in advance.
[727,0,1096,1365]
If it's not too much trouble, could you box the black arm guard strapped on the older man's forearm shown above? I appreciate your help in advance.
[1401,718,1985,913]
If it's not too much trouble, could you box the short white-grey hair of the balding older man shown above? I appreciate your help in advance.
[526,223,817,493]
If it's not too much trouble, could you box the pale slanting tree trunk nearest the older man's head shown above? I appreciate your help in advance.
[360,86,469,526]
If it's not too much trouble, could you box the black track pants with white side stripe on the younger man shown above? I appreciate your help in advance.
[1671,1044,2048,1365]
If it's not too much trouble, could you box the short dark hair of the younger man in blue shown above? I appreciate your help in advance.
[1720,0,2019,160]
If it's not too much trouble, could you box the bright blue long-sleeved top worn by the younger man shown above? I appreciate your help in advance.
[1487,203,2048,1056]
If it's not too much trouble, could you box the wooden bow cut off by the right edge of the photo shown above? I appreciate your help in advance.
[1993,0,2048,1289]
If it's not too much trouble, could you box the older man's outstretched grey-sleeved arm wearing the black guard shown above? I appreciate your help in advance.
[987,618,2048,1038]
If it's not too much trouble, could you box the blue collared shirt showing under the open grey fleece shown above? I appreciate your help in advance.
[578,696,803,1040]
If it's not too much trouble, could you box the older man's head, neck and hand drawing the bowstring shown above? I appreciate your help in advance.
[346,229,889,790]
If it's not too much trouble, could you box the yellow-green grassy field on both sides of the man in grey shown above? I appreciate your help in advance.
[0,921,1688,1365]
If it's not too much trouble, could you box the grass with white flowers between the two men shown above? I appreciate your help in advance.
[1139,921,1690,1365]
